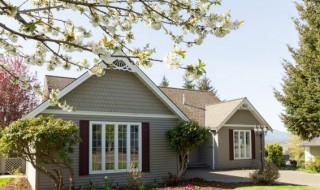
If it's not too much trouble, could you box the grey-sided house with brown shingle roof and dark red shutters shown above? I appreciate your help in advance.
[25,53,272,189]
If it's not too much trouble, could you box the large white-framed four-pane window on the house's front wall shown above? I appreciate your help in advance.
[89,122,142,174]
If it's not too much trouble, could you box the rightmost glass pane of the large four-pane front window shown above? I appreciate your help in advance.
[130,125,139,168]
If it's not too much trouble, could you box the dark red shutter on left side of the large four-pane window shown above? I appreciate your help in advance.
[79,120,89,176]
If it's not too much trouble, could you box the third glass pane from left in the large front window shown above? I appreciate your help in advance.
[118,125,127,170]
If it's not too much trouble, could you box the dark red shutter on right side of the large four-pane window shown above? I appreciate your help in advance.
[142,123,150,172]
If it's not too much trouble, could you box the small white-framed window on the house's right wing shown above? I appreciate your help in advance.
[233,130,252,159]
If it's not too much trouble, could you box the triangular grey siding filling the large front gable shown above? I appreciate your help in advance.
[50,70,173,114]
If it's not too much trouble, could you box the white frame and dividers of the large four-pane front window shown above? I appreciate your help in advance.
[89,121,142,174]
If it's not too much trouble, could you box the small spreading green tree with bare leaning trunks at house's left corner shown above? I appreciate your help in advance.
[0,116,81,190]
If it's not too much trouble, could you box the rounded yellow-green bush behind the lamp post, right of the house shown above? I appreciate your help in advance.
[266,142,286,167]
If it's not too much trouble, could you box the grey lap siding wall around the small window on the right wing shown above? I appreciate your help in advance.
[215,127,261,169]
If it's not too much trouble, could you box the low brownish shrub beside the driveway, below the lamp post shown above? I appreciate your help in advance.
[249,160,280,185]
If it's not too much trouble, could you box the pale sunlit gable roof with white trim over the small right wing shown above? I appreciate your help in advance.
[206,98,272,131]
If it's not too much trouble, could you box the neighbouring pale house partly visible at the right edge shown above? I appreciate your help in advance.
[300,137,320,162]
